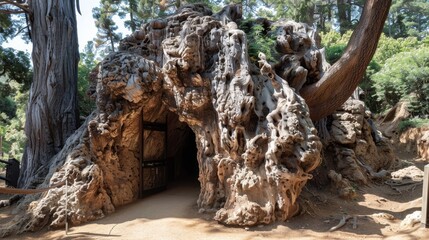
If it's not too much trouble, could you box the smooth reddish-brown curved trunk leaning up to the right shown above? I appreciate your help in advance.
[300,0,391,121]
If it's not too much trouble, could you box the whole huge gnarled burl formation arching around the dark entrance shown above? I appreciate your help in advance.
[2,4,392,235]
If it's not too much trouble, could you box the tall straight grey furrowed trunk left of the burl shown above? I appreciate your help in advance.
[19,0,79,187]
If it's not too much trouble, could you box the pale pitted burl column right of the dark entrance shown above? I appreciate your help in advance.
[157,6,321,225]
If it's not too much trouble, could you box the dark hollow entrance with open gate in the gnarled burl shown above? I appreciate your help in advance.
[140,112,198,197]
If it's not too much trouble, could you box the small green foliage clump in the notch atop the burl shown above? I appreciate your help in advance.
[240,19,276,62]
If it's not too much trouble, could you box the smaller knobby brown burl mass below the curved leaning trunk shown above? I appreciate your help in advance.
[314,97,396,199]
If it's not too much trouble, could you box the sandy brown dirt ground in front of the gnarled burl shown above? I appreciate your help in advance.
[0,149,429,240]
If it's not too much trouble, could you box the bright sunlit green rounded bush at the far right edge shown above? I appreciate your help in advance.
[372,47,429,116]
